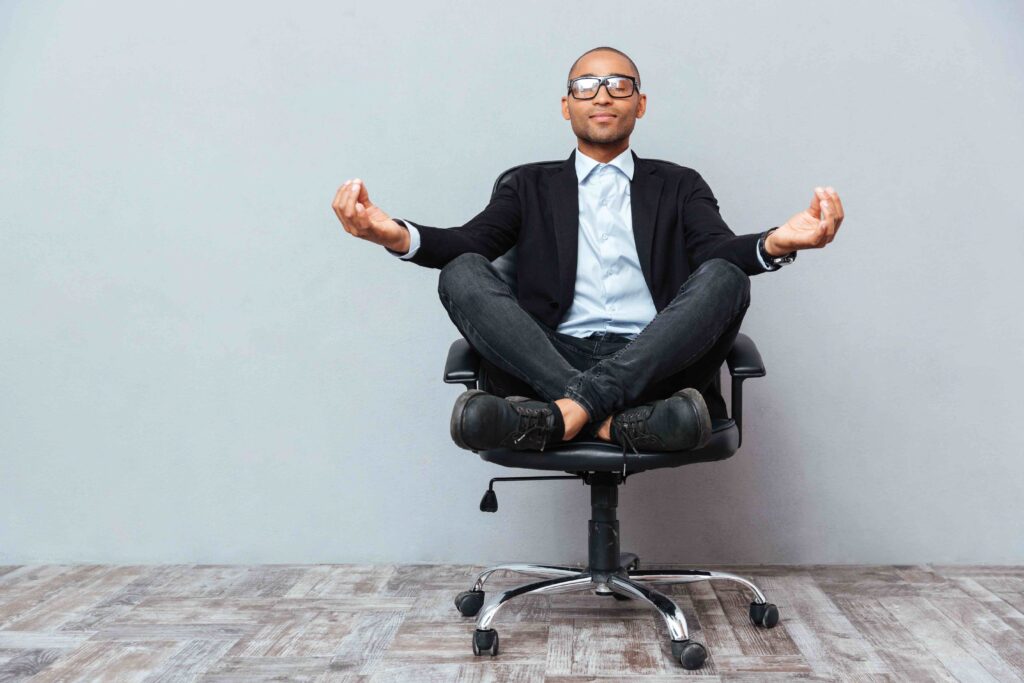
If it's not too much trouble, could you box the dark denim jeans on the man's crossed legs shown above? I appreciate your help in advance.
[437,253,751,430]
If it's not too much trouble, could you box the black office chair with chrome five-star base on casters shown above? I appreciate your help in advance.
[444,161,778,669]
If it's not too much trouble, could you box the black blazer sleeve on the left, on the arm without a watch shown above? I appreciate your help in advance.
[391,173,522,268]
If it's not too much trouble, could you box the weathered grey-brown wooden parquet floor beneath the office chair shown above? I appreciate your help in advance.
[0,564,1024,683]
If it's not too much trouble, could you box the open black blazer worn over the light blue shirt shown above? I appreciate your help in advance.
[395,150,768,330]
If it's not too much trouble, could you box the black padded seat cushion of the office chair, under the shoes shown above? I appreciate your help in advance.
[479,418,739,473]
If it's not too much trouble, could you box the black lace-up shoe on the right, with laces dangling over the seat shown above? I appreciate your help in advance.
[611,387,711,456]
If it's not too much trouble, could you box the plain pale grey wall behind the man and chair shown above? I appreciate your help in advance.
[0,1,1024,563]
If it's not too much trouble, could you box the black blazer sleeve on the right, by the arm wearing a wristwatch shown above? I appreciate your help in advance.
[682,171,769,275]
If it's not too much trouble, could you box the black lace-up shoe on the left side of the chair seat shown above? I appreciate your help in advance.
[451,389,564,451]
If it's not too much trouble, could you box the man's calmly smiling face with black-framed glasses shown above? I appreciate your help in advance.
[562,50,647,144]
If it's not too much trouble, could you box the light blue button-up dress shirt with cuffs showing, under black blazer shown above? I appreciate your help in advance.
[389,147,769,339]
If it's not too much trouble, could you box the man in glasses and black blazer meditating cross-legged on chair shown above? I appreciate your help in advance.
[332,46,844,456]
